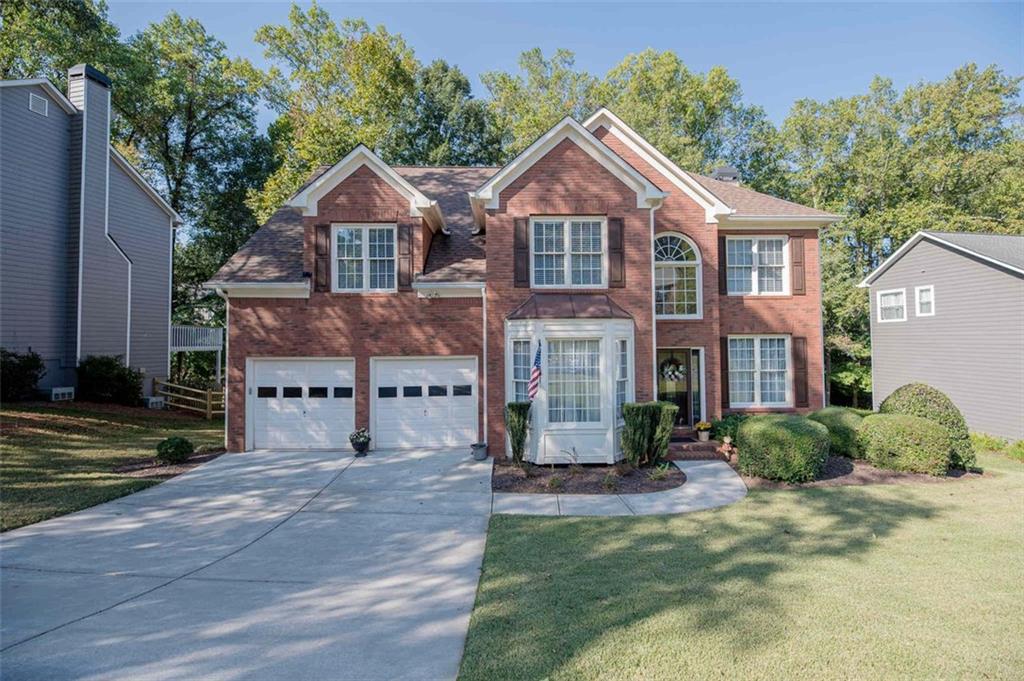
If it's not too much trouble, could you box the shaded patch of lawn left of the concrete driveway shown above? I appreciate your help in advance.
[0,406,223,530]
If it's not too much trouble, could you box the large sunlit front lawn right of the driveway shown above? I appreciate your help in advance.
[460,454,1024,681]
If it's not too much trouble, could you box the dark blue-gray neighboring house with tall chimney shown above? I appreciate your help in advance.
[0,65,180,394]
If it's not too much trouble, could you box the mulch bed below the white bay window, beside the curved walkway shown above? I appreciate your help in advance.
[490,462,686,495]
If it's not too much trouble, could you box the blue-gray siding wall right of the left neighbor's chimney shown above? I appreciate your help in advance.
[110,161,172,382]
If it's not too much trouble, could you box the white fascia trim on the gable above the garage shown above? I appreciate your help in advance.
[286,144,449,233]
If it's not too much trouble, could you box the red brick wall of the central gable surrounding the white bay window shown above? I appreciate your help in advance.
[486,139,653,456]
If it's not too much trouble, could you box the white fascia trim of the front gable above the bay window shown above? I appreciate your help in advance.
[469,117,669,212]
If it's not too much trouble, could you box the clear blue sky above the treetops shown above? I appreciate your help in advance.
[110,0,1024,129]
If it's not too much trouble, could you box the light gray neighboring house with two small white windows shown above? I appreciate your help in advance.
[860,231,1024,439]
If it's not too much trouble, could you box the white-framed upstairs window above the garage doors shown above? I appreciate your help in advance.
[331,224,395,291]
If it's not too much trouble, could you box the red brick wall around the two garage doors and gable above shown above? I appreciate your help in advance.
[227,167,483,452]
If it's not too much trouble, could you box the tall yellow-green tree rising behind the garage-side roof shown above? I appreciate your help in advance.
[250,2,419,219]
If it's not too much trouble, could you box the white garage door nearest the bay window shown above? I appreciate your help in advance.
[372,357,477,449]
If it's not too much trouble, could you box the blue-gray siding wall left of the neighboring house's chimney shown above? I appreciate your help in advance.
[0,86,74,388]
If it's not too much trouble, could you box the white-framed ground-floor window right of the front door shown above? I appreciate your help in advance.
[728,336,792,407]
